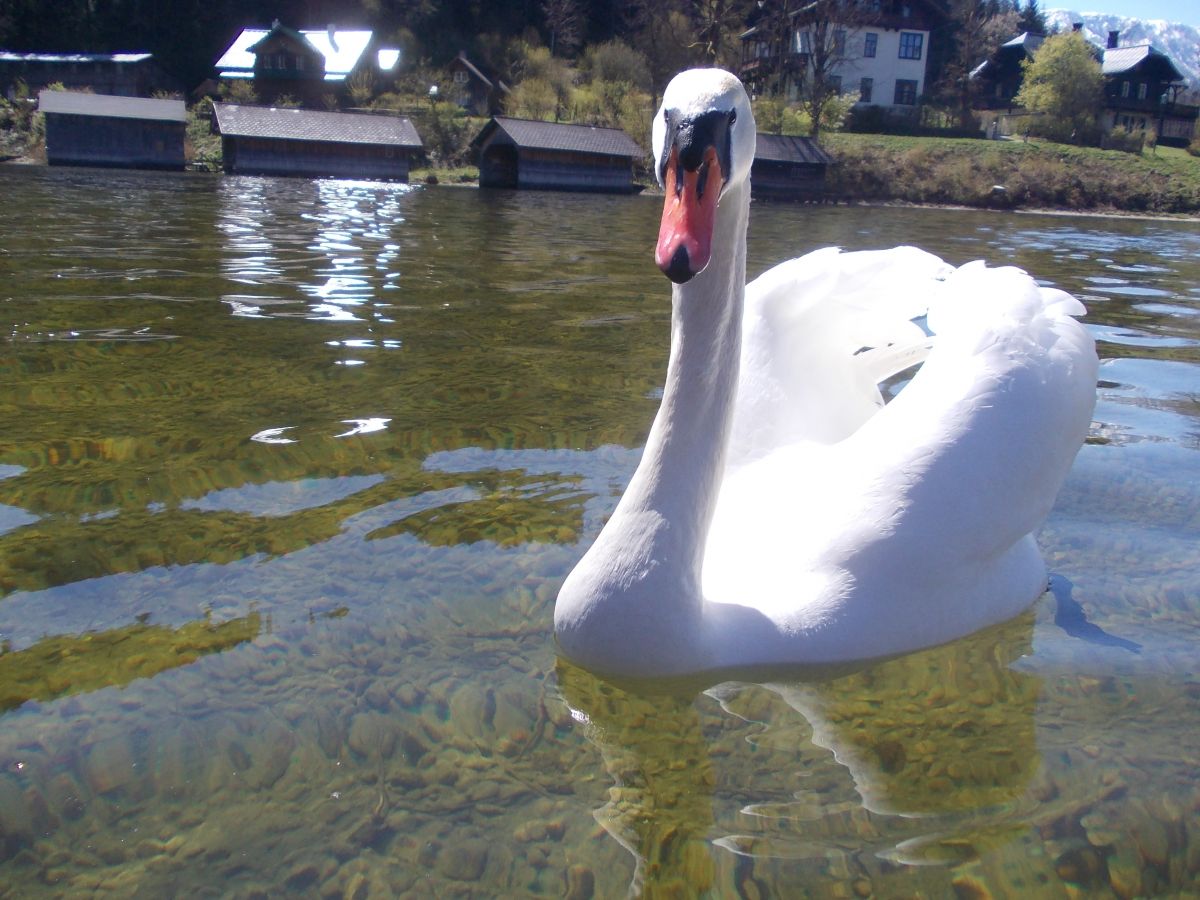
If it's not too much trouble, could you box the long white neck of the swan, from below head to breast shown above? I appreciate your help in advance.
[554,184,750,672]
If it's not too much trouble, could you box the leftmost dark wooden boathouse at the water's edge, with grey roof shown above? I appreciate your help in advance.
[37,90,187,169]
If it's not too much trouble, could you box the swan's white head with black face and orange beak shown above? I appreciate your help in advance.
[654,68,756,284]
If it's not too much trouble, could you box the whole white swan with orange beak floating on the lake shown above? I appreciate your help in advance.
[554,70,1098,677]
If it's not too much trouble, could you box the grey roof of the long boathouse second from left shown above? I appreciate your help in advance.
[212,103,421,150]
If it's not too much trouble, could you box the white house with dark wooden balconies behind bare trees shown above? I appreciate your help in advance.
[740,0,936,112]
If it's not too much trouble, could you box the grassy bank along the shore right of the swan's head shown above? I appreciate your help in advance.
[822,133,1200,214]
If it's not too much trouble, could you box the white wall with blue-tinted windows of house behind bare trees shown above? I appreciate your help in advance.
[788,28,929,109]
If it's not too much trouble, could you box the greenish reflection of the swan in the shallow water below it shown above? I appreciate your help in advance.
[558,613,1054,896]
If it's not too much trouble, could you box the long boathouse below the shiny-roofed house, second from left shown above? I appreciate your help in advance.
[212,103,424,181]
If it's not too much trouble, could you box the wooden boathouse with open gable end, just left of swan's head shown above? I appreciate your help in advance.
[472,115,644,193]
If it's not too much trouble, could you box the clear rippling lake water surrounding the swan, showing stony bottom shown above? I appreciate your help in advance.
[0,167,1200,899]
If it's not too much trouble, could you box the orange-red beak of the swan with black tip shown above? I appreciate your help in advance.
[654,146,724,284]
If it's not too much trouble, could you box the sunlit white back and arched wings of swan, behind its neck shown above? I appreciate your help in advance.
[703,248,1097,660]
